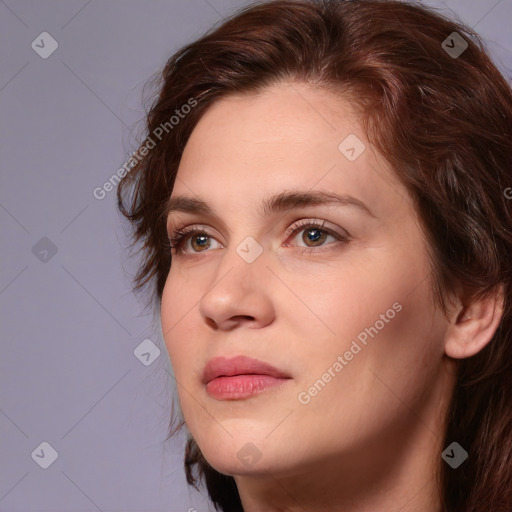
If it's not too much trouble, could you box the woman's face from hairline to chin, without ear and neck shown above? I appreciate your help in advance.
[161,82,448,482]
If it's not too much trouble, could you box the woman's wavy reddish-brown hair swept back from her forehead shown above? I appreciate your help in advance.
[118,0,512,512]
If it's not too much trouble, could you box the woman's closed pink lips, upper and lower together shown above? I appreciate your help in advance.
[203,356,291,400]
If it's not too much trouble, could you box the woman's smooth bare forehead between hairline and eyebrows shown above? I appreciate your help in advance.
[172,82,410,219]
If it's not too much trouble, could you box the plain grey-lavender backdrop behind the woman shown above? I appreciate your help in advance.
[0,0,512,512]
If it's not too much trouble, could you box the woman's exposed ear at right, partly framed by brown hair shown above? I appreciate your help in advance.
[445,285,504,359]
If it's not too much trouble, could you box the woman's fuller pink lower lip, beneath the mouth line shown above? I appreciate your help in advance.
[206,374,289,400]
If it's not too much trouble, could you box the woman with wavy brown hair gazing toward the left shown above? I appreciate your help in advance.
[118,0,512,512]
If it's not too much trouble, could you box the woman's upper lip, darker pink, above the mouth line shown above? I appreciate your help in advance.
[203,356,290,384]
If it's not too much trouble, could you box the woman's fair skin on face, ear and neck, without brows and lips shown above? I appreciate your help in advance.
[161,82,499,512]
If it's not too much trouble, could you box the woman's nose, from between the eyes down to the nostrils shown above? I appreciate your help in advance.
[199,241,275,331]
